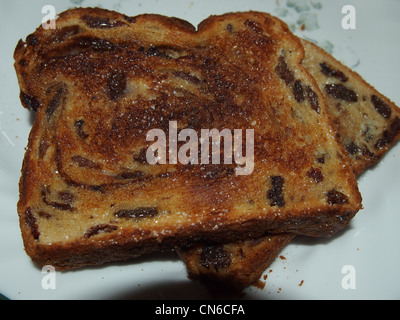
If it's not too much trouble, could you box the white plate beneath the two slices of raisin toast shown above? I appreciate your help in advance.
[0,0,400,299]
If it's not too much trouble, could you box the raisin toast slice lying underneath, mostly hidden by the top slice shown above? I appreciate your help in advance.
[178,40,400,291]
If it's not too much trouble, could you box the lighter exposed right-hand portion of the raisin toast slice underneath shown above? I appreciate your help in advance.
[302,40,400,175]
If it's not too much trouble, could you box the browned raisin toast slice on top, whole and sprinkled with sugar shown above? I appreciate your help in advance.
[14,8,361,270]
